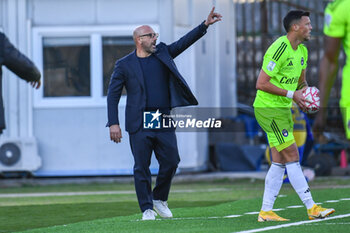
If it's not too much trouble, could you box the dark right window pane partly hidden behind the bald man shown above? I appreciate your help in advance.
[102,37,135,96]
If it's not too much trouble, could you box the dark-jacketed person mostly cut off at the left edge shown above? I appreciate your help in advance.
[0,32,41,135]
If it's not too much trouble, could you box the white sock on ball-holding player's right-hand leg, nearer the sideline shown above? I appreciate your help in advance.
[286,162,315,209]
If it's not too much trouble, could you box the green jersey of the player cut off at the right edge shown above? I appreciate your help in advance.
[323,0,350,105]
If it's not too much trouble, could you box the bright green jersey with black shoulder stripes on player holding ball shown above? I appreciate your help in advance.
[253,36,308,108]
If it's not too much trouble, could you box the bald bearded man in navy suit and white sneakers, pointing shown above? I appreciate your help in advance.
[107,8,221,220]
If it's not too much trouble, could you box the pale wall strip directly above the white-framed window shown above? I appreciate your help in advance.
[30,0,159,26]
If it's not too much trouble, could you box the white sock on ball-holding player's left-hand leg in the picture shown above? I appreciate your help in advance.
[261,163,286,211]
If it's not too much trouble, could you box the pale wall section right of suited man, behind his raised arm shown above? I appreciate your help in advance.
[174,0,236,170]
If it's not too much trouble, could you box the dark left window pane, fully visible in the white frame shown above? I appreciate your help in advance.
[43,37,91,97]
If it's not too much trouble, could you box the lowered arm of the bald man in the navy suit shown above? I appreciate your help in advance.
[107,61,125,143]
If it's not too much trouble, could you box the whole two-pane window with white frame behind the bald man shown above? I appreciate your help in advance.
[32,25,159,108]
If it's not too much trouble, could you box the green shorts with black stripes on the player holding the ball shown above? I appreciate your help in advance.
[254,107,295,152]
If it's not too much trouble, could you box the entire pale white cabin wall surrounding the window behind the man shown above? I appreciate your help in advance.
[0,0,236,176]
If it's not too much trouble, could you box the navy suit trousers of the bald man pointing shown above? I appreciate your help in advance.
[129,130,180,212]
